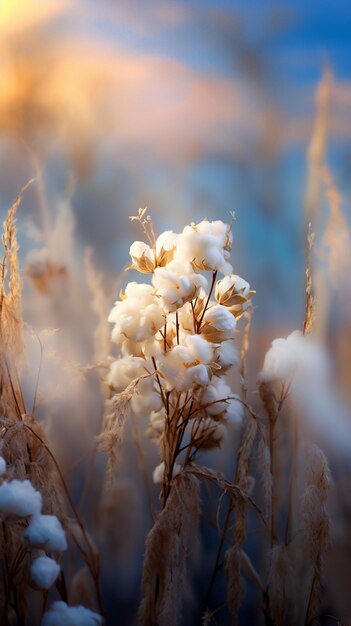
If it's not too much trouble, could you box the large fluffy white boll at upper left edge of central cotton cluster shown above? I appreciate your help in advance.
[108,282,164,345]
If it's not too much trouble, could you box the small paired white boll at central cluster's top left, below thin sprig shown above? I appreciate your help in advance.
[129,230,177,274]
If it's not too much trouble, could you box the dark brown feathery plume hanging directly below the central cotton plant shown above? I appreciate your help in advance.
[139,473,200,626]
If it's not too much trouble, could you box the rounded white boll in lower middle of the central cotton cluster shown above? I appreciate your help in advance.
[158,334,213,391]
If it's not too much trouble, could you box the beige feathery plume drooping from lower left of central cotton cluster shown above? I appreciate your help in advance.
[97,378,141,479]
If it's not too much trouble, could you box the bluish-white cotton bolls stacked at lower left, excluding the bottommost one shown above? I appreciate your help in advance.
[0,470,67,589]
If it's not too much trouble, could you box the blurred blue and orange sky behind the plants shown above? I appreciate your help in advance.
[0,0,351,326]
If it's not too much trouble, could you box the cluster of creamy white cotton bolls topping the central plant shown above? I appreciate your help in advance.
[107,210,254,482]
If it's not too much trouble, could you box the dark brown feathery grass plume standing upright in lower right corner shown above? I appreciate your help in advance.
[301,444,331,624]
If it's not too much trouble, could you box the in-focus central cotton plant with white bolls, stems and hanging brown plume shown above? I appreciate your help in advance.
[99,209,254,626]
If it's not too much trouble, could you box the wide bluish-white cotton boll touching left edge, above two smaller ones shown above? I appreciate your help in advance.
[0,479,41,517]
